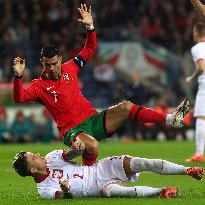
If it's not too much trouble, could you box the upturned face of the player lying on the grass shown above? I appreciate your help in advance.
[26,152,46,171]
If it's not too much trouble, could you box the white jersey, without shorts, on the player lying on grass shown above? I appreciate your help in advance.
[35,150,98,198]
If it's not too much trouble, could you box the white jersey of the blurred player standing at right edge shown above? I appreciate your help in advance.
[191,42,205,94]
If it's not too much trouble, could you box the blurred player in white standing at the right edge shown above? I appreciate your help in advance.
[186,22,205,162]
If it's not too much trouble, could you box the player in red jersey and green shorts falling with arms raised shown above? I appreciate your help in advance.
[13,4,189,165]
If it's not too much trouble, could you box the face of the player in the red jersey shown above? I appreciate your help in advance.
[41,55,62,80]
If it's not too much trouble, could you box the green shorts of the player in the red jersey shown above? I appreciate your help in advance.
[64,110,106,147]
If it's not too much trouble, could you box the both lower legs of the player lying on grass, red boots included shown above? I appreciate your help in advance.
[101,156,203,198]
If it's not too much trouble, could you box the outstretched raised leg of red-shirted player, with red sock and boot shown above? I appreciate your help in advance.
[105,99,190,134]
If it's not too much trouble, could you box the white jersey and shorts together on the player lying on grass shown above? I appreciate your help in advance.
[35,150,139,199]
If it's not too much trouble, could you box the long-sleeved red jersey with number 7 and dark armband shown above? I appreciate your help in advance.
[13,31,97,138]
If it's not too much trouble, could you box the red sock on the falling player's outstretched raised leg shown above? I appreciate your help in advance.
[129,105,167,123]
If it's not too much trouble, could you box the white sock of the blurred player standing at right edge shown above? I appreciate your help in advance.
[195,119,205,155]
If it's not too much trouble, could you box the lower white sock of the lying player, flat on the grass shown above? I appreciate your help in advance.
[106,184,163,197]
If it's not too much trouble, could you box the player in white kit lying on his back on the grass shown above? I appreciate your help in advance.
[13,150,203,199]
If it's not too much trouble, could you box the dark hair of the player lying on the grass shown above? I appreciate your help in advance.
[12,151,30,177]
